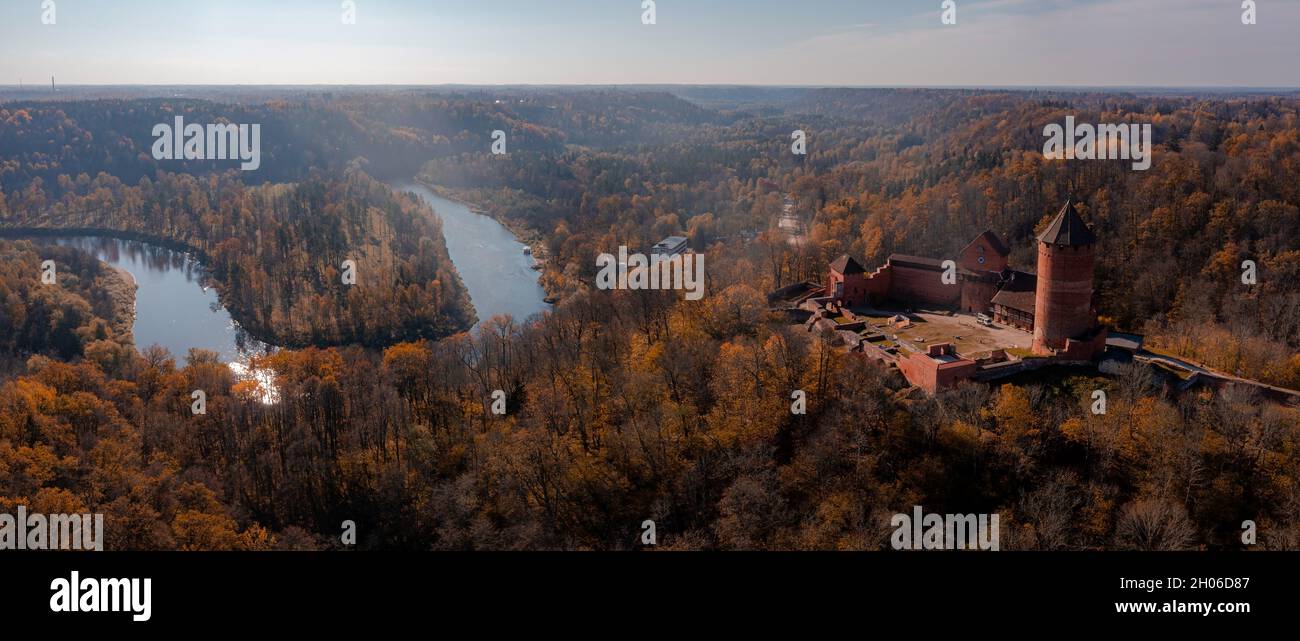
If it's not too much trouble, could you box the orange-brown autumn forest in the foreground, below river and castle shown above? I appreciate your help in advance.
[0,244,1300,550]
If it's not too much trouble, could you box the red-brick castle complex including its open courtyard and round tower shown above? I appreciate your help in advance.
[800,198,1108,394]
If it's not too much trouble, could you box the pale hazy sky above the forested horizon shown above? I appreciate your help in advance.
[0,0,1300,87]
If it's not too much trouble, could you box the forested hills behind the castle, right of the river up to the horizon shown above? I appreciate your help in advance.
[421,90,1300,387]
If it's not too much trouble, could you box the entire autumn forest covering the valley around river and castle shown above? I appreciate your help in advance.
[0,88,1300,550]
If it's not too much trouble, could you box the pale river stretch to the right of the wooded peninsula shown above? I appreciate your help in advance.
[393,182,551,325]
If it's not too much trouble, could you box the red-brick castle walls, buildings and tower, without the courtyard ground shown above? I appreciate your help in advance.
[813,199,1106,393]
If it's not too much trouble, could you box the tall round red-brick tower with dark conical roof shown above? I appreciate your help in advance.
[1034,198,1097,354]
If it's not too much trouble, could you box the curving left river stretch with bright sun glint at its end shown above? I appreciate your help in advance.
[31,237,269,363]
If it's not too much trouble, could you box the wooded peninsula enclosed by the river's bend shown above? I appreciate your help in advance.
[0,169,475,347]
